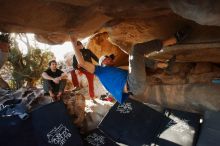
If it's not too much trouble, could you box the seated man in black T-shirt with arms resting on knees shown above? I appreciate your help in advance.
[42,60,66,101]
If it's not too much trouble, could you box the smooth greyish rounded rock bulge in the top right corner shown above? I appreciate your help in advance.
[170,0,220,26]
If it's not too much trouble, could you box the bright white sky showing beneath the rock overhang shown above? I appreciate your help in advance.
[17,34,89,61]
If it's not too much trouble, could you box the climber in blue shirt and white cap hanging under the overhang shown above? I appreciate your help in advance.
[70,26,189,104]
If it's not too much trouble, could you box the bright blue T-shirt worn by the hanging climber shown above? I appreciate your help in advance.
[94,66,128,104]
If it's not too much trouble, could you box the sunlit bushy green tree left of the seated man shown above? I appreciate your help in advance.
[8,34,54,89]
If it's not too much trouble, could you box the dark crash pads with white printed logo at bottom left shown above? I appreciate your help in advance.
[0,101,83,146]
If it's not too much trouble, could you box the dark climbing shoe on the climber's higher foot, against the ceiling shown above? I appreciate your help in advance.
[174,25,192,43]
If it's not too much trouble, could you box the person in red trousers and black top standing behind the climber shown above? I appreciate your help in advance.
[71,41,99,99]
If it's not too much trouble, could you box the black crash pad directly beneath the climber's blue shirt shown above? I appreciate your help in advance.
[98,99,167,146]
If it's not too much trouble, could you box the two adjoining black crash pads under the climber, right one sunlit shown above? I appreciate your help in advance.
[98,99,201,146]
